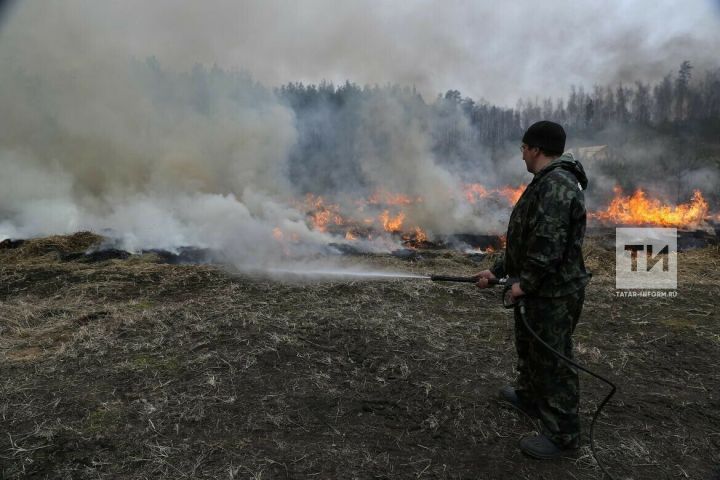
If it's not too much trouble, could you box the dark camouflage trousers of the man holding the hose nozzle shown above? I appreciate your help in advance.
[515,289,585,446]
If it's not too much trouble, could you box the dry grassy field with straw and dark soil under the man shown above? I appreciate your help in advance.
[0,234,720,480]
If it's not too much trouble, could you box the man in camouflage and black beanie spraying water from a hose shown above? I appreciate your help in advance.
[478,121,591,459]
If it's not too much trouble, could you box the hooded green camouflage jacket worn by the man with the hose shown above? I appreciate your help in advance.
[491,153,591,297]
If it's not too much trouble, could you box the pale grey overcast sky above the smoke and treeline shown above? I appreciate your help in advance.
[0,0,720,106]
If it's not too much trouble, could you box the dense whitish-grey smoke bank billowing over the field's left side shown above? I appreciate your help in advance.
[0,59,338,259]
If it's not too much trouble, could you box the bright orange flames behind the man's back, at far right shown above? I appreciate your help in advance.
[590,187,709,227]
